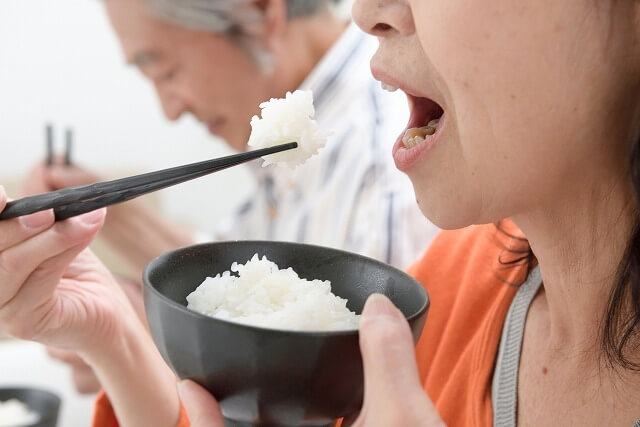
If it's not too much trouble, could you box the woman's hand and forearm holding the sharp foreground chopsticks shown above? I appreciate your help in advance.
[0,187,179,427]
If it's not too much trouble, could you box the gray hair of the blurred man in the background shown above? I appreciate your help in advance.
[148,0,339,71]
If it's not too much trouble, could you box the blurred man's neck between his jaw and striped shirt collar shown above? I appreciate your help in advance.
[272,10,348,97]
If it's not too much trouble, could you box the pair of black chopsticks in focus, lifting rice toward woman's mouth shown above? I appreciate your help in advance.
[0,142,298,221]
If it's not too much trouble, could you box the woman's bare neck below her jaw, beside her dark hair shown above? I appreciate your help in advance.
[513,166,634,362]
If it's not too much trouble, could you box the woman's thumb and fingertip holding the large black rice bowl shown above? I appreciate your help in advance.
[178,295,444,427]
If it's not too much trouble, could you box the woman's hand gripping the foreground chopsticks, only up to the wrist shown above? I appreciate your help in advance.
[0,185,128,351]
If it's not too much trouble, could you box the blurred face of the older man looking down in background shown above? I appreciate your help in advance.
[105,0,271,151]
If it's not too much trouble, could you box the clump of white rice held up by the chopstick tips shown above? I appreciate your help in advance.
[249,90,327,167]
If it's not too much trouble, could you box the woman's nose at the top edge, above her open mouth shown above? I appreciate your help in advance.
[352,0,412,37]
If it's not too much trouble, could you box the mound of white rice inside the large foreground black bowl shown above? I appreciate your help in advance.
[187,254,360,331]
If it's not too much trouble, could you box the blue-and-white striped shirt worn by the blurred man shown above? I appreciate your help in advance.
[216,24,438,268]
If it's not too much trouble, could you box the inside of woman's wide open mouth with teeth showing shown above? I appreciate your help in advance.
[382,83,444,148]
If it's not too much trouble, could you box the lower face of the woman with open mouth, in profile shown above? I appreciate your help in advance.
[353,0,640,228]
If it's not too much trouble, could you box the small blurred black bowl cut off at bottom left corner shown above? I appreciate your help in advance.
[0,387,60,427]
